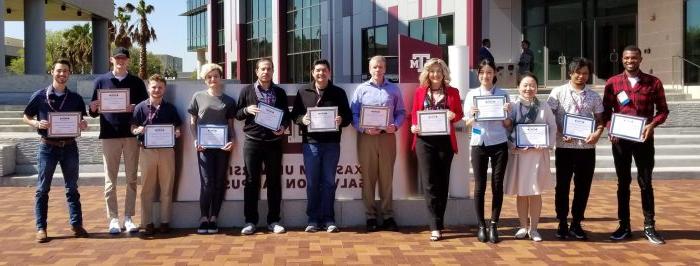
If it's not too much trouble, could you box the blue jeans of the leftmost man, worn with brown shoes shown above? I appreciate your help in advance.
[34,142,83,230]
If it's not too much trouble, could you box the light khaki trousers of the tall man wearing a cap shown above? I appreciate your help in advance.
[102,137,139,219]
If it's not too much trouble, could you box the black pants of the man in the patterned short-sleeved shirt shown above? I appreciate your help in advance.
[554,148,592,224]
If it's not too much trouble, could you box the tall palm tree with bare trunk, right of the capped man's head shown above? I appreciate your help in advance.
[124,0,156,79]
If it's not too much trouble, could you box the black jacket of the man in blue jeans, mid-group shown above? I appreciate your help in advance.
[292,81,352,143]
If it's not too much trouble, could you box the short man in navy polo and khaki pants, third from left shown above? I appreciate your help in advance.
[131,74,182,235]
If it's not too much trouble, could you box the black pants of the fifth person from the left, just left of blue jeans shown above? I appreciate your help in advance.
[243,138,282,224]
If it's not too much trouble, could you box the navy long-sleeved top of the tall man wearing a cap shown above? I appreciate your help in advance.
[89,71,148,139]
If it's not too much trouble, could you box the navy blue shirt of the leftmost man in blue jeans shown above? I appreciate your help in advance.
[24,86,87,137]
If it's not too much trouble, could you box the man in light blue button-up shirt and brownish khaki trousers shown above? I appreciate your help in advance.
[350,56,406,232]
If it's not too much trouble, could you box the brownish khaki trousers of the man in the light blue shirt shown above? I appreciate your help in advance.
[357,134,396,219]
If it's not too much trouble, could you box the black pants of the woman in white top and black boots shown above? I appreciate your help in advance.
[471,142,508,226]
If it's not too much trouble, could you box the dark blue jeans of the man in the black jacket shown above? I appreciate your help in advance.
[303,143,340,224]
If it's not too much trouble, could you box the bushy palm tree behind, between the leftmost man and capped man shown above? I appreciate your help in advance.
[63,23,92,73]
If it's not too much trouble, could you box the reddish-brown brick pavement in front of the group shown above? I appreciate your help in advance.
[0,180,700,265]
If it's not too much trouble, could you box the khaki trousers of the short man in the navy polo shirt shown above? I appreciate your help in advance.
[139,148,175,226]
